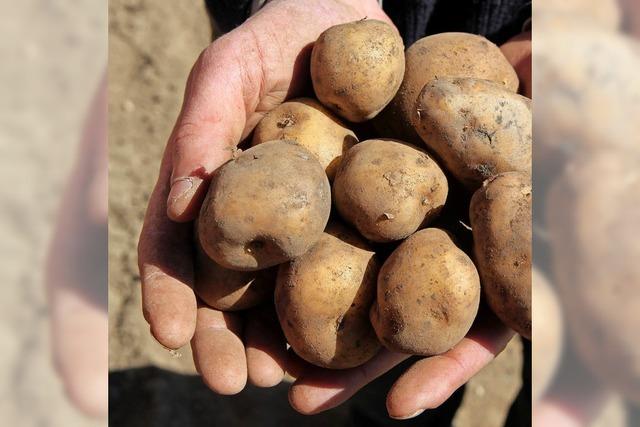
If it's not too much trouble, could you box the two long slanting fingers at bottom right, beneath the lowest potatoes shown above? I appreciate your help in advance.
[289,308,514,419]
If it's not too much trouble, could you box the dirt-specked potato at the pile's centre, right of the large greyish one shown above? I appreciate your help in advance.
[333,139,448,242]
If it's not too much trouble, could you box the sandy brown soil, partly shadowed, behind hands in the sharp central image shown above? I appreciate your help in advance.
[109,0,522,427]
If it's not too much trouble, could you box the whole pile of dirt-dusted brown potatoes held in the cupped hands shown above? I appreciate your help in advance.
[195,19,531,369]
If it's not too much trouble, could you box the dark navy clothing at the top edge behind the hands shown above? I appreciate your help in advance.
[206,0,531,46]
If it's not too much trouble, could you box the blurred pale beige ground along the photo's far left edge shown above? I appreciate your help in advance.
[0,0,107,427]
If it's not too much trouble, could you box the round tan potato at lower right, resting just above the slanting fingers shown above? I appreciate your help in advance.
[371,228,480,356]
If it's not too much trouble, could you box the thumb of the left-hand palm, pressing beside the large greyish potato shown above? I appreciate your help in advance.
[167,33,261,222]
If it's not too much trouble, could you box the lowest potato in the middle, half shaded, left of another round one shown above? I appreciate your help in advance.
[275,224,380,369]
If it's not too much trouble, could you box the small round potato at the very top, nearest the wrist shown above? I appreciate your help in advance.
[311,19,404,123]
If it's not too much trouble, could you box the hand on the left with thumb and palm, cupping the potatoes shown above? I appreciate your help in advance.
[138,0,389,394]
